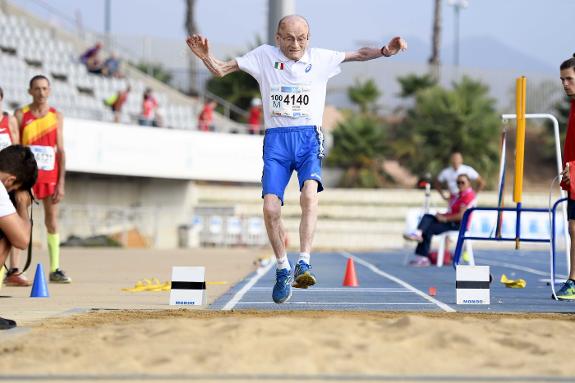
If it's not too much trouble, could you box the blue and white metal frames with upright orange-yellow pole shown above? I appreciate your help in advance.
[453,77,571,297]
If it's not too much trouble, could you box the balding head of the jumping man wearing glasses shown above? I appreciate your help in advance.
[276,15,309,61]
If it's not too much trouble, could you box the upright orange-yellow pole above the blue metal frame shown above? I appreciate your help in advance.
[513,76,527,203]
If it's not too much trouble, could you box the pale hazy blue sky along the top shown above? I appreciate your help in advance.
[12,0,575,68]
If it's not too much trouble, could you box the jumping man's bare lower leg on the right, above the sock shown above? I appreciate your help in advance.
[299,180,319,254]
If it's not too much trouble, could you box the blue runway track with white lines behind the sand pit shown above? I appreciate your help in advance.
[210,249,575,312]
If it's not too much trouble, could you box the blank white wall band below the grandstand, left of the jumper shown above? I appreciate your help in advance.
[64,118,263,182]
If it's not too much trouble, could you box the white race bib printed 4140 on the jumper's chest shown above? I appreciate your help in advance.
[270,85,311,118]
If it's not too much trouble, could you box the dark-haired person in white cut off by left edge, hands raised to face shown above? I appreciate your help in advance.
[0,145,38,330]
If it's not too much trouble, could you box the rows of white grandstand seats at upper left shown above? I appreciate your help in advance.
[0,6,242,131]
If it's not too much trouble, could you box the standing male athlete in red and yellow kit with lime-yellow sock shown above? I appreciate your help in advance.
[16,75,72,283]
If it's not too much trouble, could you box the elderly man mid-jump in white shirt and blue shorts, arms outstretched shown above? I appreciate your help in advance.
[187,15,407,303]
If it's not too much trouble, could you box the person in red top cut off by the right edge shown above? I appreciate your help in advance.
[556,55,575,300]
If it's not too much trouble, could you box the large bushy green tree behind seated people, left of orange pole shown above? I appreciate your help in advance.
[396,77,500,179]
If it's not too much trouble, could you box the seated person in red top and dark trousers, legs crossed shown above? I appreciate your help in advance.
[403,174,476,266]
